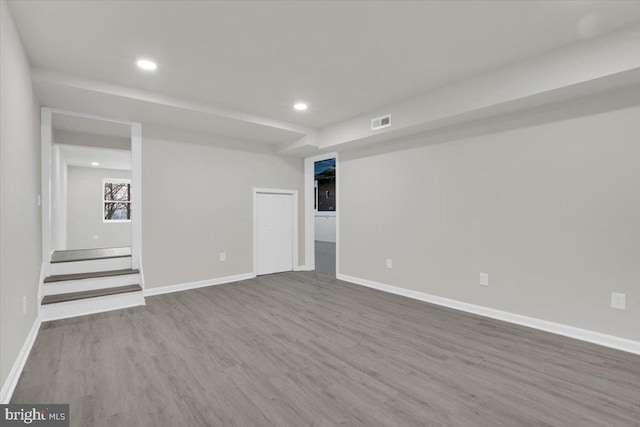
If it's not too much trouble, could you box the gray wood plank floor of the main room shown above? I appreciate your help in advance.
[12,272,640,427]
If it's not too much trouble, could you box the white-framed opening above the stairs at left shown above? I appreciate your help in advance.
[42,107,142,276]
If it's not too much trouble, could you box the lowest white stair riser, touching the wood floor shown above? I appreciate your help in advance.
[40,291,144,322]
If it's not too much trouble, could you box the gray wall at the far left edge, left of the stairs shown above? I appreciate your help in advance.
[0,1,41,387]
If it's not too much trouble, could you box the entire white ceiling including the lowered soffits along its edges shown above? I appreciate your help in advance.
[9,0,640,156]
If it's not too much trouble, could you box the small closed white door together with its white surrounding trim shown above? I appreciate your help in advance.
[253,188,298,275]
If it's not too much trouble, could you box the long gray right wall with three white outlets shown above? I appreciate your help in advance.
[338,107,640,340]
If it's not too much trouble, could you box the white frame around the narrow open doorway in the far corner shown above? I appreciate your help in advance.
[304,152,340,277]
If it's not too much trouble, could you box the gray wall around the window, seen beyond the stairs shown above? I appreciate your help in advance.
[67,166,135,249]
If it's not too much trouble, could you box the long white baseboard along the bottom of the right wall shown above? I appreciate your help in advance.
[336,274,640,354]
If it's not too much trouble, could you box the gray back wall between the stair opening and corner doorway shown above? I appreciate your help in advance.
[142,138,304,288]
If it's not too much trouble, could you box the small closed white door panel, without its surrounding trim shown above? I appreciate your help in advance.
[255,193,294,274]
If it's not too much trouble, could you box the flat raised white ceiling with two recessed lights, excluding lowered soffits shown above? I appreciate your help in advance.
[10,1,640,128]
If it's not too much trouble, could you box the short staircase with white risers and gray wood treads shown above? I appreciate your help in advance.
[40,248,144,321]
